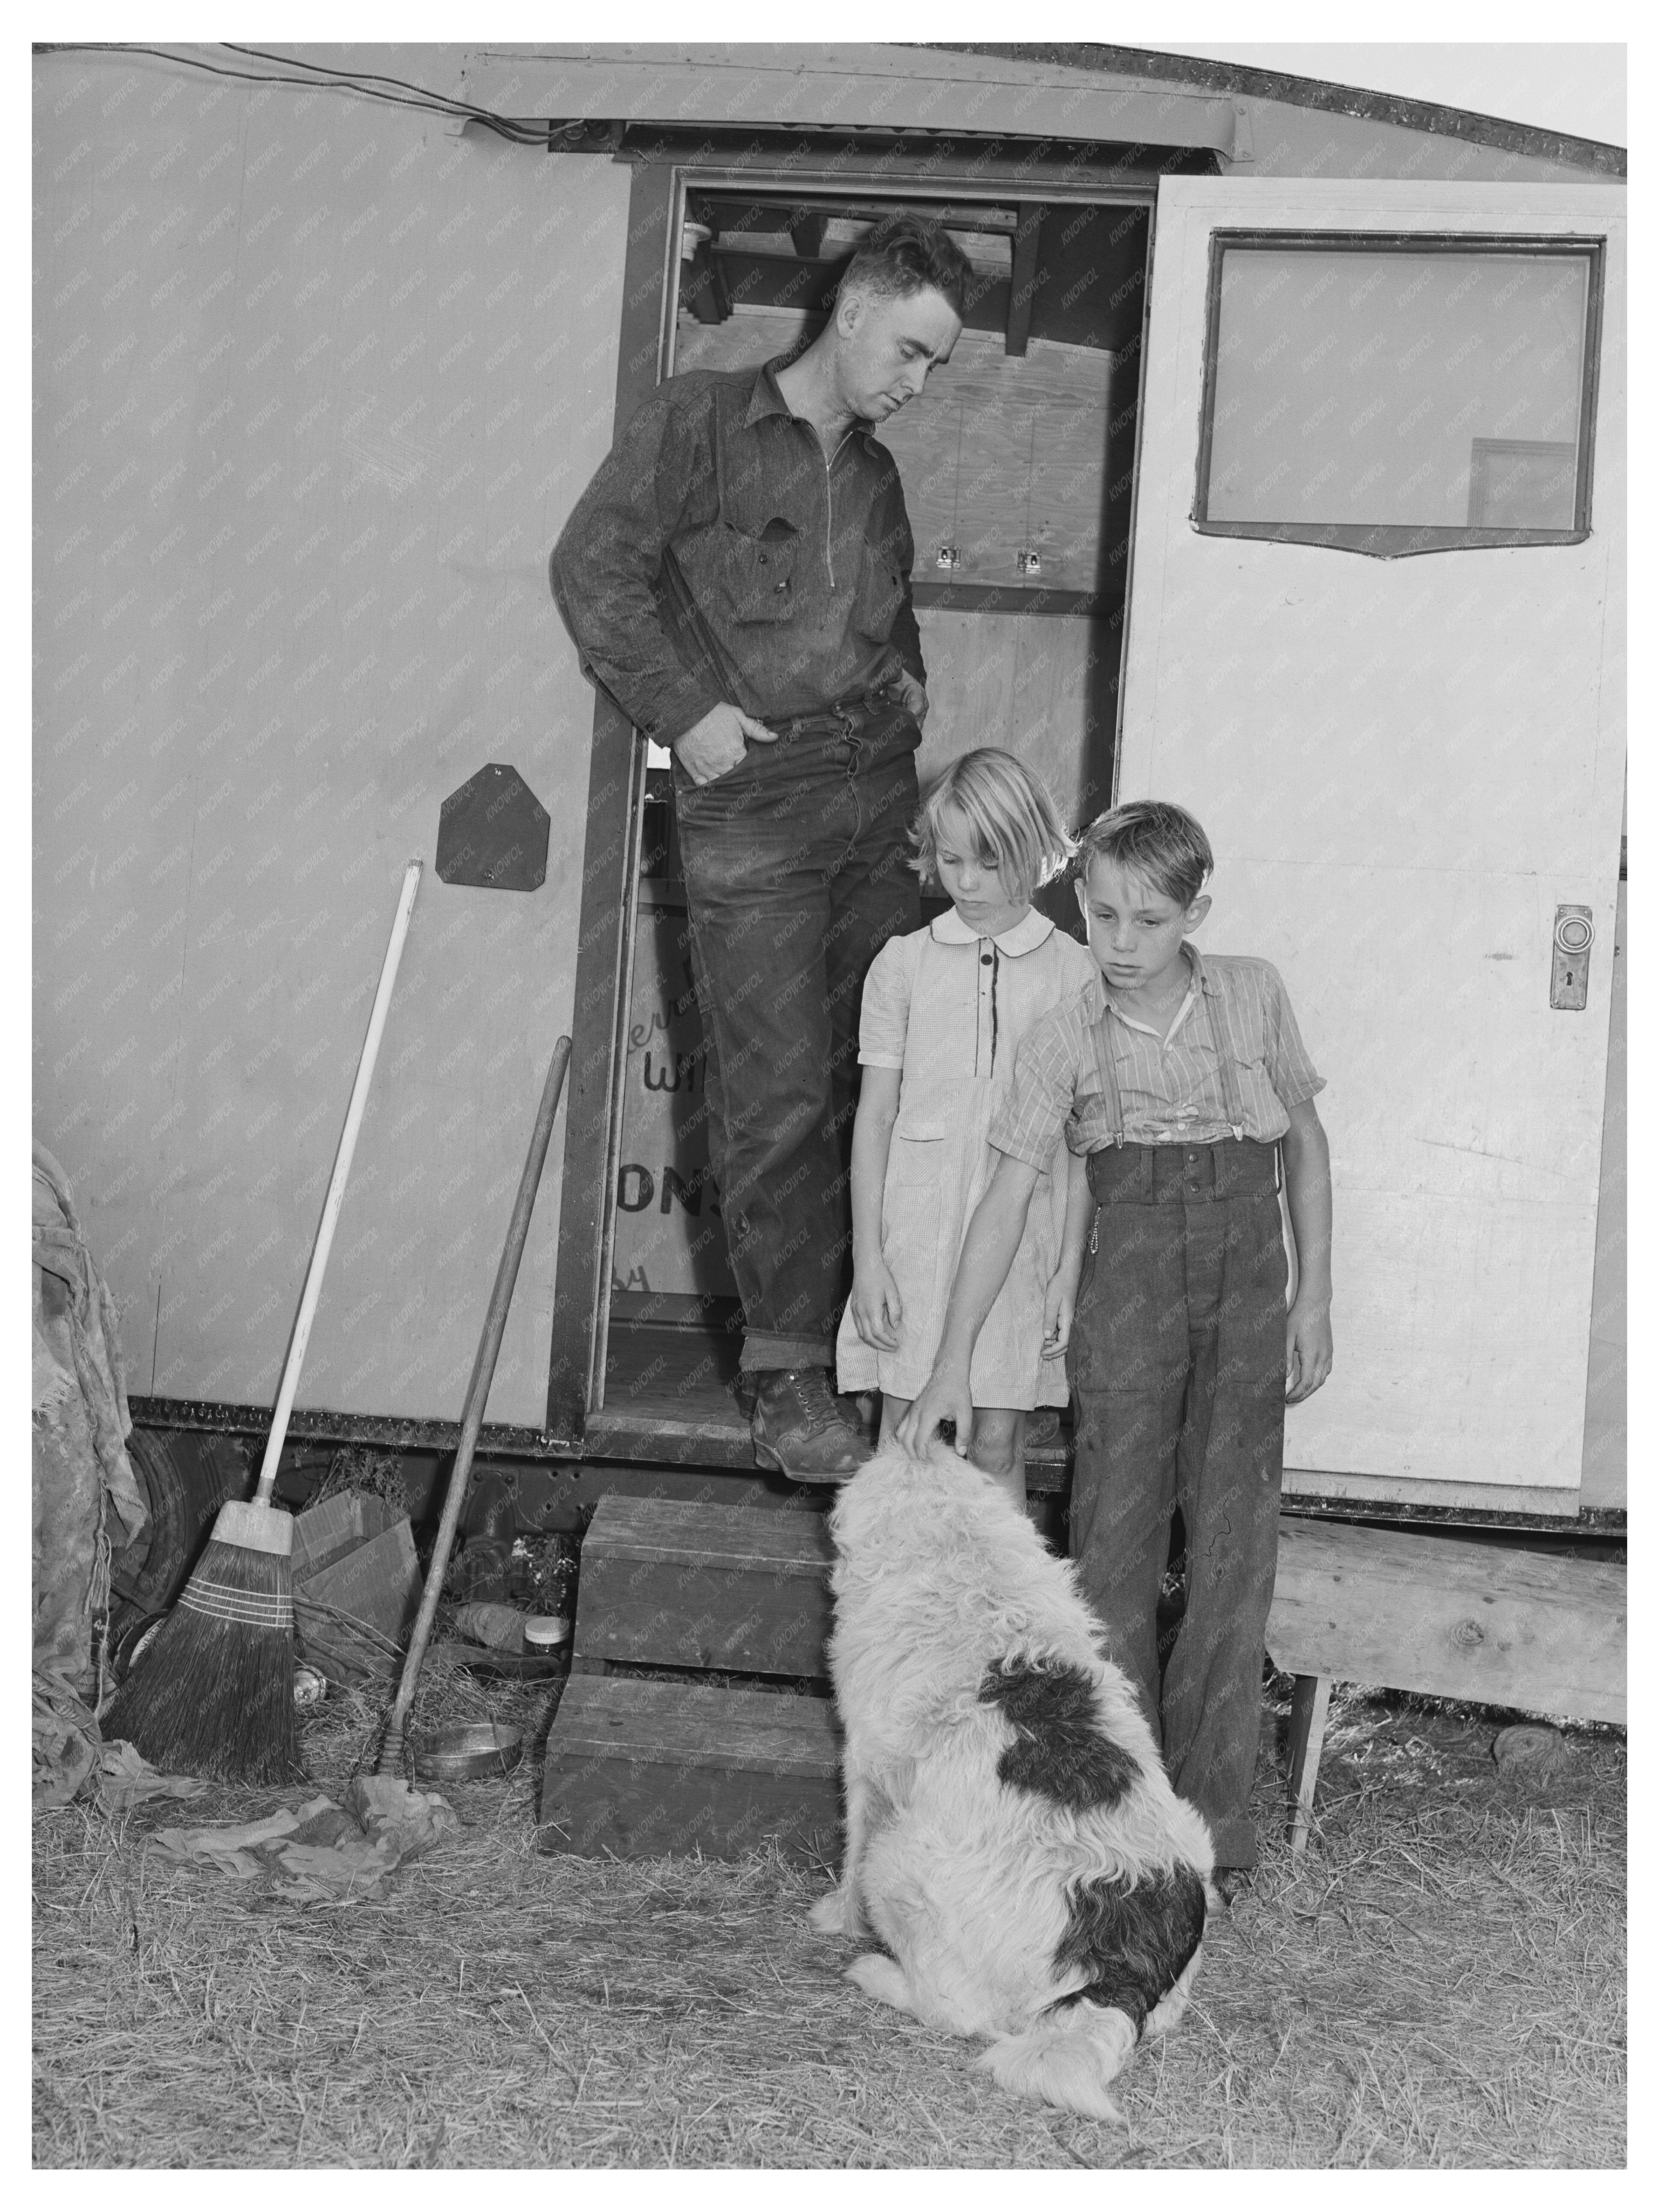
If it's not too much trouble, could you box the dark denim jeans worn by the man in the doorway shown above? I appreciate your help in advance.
[675,710,938,1371]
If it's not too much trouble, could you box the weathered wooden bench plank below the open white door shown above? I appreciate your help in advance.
[1267,1517,1626,1721]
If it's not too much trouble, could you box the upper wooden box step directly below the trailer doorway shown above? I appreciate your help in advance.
[571,1497,834,1681]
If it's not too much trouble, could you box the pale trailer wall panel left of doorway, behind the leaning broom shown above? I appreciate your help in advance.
[35,57,628,1422]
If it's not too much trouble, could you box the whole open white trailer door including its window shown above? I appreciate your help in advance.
[1119,177,1626,1511]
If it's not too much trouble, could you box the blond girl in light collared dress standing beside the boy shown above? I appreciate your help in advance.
[836,748,1099,1502]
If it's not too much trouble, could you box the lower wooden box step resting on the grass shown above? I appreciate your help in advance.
[538,1674,841,1865]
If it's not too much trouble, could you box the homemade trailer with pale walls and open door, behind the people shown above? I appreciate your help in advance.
[33,46,1626,1592]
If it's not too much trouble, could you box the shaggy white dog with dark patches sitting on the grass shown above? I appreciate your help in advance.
[812,1449,1215,2119]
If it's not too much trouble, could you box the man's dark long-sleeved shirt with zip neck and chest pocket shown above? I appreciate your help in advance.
[551,363,925,746]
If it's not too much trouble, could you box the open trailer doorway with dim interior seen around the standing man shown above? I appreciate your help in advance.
[589,175,1152,1464]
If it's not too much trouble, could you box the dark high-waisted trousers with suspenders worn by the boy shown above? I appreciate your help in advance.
[1070,1139,1287,1867]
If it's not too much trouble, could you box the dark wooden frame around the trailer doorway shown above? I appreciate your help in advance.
[546,135,1188,1445]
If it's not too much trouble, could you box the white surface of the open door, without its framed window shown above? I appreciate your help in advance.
[1121,179,1624,1495]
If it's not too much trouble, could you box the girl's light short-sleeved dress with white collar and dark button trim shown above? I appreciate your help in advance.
[836,907,1095,1409]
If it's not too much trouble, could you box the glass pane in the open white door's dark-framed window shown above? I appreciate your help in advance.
[1201,246,1590,531]
